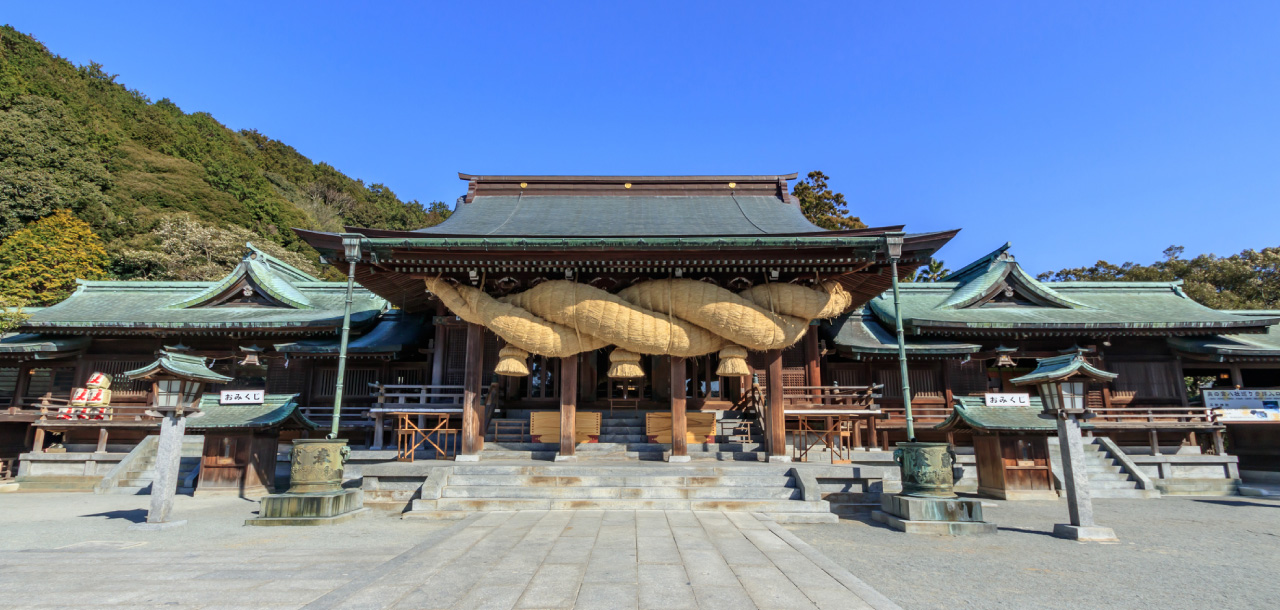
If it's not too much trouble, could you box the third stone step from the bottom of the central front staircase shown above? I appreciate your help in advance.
[448,468,795,487]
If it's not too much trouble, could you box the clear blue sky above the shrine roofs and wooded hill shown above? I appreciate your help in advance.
[3,0,1280,271]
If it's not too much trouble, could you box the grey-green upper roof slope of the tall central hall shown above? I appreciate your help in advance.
[416,194,823,237]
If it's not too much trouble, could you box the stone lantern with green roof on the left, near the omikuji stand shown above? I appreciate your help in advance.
[124,348,232,529]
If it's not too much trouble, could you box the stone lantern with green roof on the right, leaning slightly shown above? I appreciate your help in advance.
[1011,352,1116,542]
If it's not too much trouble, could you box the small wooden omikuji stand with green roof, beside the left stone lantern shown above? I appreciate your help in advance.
[188,391,320,497]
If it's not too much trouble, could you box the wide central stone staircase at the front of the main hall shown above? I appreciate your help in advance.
[403,463,838,523]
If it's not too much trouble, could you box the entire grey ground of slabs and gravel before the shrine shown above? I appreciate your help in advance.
[0,494,1280,610]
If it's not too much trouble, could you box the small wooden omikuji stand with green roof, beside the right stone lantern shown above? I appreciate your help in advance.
[934,396,1089,500]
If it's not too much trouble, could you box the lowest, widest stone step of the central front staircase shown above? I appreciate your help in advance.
[430,497,831,514]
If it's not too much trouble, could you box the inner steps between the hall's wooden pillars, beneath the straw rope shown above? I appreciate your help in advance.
[480,411,767,462]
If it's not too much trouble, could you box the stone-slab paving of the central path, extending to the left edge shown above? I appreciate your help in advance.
[0,501,897,610]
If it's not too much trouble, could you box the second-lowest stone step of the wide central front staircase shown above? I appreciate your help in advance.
[440,485,803,500]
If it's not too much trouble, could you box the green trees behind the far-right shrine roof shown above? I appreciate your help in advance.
[1037,246,1280,309]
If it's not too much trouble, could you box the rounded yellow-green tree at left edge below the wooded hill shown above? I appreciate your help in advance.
[0,210,108,304]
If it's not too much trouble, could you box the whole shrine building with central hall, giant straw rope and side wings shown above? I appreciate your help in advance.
[0,174,1280,506]
